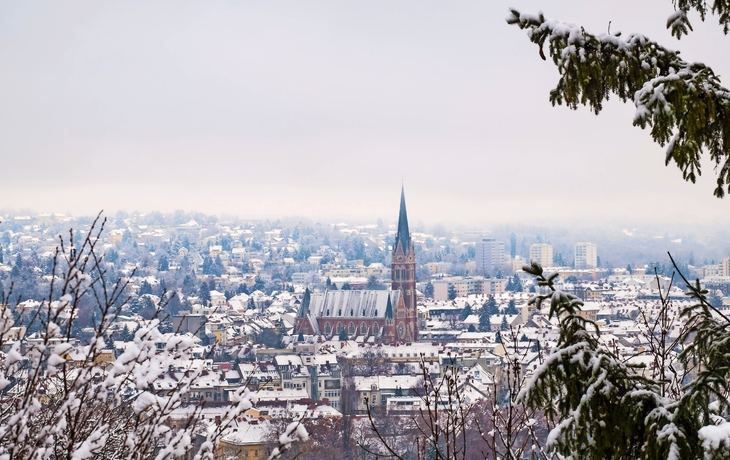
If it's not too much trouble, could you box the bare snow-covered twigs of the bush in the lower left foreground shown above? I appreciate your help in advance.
[0,218,307,460]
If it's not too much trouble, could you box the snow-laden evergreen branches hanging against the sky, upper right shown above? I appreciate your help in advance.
[507,6,730,198]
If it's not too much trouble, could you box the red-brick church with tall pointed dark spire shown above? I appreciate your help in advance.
[294,188,418,344]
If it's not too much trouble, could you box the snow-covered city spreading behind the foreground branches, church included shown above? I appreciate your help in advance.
[0,190,730,458]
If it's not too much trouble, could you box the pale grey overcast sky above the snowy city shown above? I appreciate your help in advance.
[0,0,730,224]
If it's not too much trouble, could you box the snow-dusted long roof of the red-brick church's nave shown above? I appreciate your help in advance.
[300,290,401,319]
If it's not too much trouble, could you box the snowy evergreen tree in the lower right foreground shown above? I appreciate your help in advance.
[518,255,730,460]
